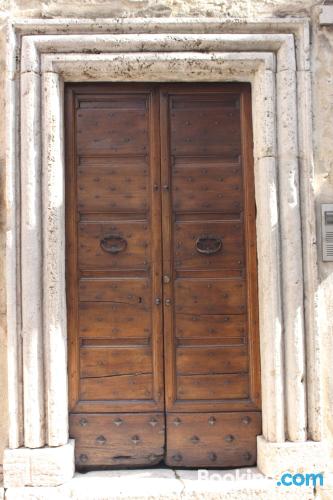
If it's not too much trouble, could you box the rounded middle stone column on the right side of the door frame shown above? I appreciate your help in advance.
[276,62,307,441]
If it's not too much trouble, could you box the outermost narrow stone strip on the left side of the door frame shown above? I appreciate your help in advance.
[5,22,23,448]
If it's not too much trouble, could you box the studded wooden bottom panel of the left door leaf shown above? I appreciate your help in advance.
[69,413,165,469]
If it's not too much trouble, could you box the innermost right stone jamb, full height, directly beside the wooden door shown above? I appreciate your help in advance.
[252,70,285,442]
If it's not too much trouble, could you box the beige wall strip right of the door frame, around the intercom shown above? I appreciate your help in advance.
[312,15,333,456]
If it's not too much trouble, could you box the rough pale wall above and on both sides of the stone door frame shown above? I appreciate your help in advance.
[0,0,333,472]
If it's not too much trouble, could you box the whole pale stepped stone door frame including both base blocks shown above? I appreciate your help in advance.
[4,18,326,487]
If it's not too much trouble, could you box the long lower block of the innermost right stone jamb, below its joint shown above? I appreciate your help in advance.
[255,157,285,442]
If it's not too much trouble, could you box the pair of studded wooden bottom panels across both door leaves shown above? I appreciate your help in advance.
[70,412,261,469]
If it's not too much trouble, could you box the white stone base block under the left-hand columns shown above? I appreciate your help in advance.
[3,440,75,488]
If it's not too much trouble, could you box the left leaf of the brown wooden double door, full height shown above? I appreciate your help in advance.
[66,84,164,467]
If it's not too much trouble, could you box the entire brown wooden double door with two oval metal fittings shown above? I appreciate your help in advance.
[65,83,261,468]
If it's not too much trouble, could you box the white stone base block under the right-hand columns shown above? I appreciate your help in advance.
[257,436,328,478]
